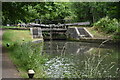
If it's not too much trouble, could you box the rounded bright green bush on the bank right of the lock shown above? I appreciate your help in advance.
[93,16,120,39]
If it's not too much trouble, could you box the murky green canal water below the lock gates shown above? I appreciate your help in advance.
[43,41,120,78]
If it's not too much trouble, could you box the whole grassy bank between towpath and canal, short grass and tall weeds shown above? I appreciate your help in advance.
[3,30,47,78]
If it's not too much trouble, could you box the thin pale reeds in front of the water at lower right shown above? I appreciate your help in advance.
[75,52,119,78]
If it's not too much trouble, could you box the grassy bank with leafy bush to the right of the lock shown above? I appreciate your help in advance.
[79,16,120,40]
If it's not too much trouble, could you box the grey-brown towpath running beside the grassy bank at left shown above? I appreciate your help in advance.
[0,30,20,78]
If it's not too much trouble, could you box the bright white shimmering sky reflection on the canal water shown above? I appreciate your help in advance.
[45,57,75,78]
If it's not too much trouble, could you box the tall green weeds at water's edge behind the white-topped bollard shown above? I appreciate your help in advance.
[9,42,48,78]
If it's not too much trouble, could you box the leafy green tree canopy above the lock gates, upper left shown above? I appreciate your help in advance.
[3,2,71,24]
